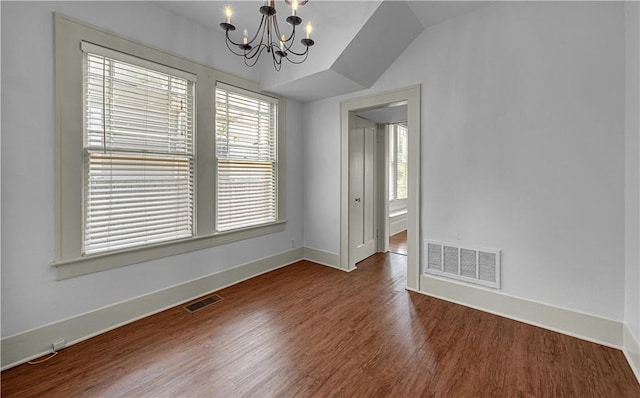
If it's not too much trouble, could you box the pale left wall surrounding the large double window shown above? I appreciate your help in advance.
[1,2,303,337]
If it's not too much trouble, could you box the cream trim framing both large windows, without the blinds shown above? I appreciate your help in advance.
[51,14,286,280]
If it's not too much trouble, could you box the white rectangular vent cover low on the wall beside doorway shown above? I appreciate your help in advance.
[424,240,500,289]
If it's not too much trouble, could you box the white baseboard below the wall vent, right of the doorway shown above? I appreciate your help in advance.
[418,275,623,349]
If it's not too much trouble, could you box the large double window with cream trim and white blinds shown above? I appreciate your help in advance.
[52,14,286,279]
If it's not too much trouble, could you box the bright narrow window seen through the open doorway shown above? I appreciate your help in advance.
[388,124,409,201]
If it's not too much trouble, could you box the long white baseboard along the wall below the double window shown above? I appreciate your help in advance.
[0,247,306,370]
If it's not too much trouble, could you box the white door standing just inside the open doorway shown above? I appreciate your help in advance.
[349,116,377,264]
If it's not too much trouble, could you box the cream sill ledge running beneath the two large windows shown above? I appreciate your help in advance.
[51,220,286,280]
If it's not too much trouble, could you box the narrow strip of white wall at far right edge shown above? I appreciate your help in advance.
[624,2,640,346]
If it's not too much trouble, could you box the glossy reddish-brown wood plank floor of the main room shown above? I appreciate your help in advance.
[1,254,640,398]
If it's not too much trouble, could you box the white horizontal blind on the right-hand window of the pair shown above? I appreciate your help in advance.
[216,84,278,231]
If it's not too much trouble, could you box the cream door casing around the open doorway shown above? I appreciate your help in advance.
[340,86,420,290]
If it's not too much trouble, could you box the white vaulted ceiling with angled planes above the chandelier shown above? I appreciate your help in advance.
[155,0,493,102]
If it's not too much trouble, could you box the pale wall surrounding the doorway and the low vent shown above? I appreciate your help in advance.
[303,2,625,320]
